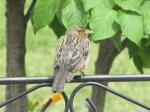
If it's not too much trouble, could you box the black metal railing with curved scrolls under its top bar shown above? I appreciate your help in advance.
[0,74,150,112]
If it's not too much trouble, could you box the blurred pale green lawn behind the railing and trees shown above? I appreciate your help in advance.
[0,0,150,112]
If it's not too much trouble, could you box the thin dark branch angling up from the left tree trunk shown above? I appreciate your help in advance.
[25,0,37,23]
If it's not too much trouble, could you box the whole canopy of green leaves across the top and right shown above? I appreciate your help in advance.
[32,0,150,72]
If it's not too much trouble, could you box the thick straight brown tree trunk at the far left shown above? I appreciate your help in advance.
[6,0,28,112]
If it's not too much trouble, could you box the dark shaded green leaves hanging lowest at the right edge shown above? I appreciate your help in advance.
[127,38,150,73]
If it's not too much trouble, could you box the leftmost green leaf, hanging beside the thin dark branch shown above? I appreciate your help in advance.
[32,0,58,33]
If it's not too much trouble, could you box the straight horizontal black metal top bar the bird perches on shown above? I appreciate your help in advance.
[0,74,150,85]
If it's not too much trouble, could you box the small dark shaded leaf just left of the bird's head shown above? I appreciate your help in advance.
[50,16,66,38]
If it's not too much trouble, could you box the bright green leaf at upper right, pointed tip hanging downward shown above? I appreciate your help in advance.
[117,12,144,45]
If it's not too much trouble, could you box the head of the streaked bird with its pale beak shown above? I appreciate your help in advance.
[66,26,93,38]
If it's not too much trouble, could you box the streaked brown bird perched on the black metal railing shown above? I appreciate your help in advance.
[52,26,92,93]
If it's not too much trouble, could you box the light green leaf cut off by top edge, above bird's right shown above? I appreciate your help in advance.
[82,0,114,11]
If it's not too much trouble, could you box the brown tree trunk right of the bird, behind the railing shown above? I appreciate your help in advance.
[90,39,119,112]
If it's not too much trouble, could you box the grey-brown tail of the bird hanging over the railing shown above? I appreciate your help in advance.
[52,69,69,93]
